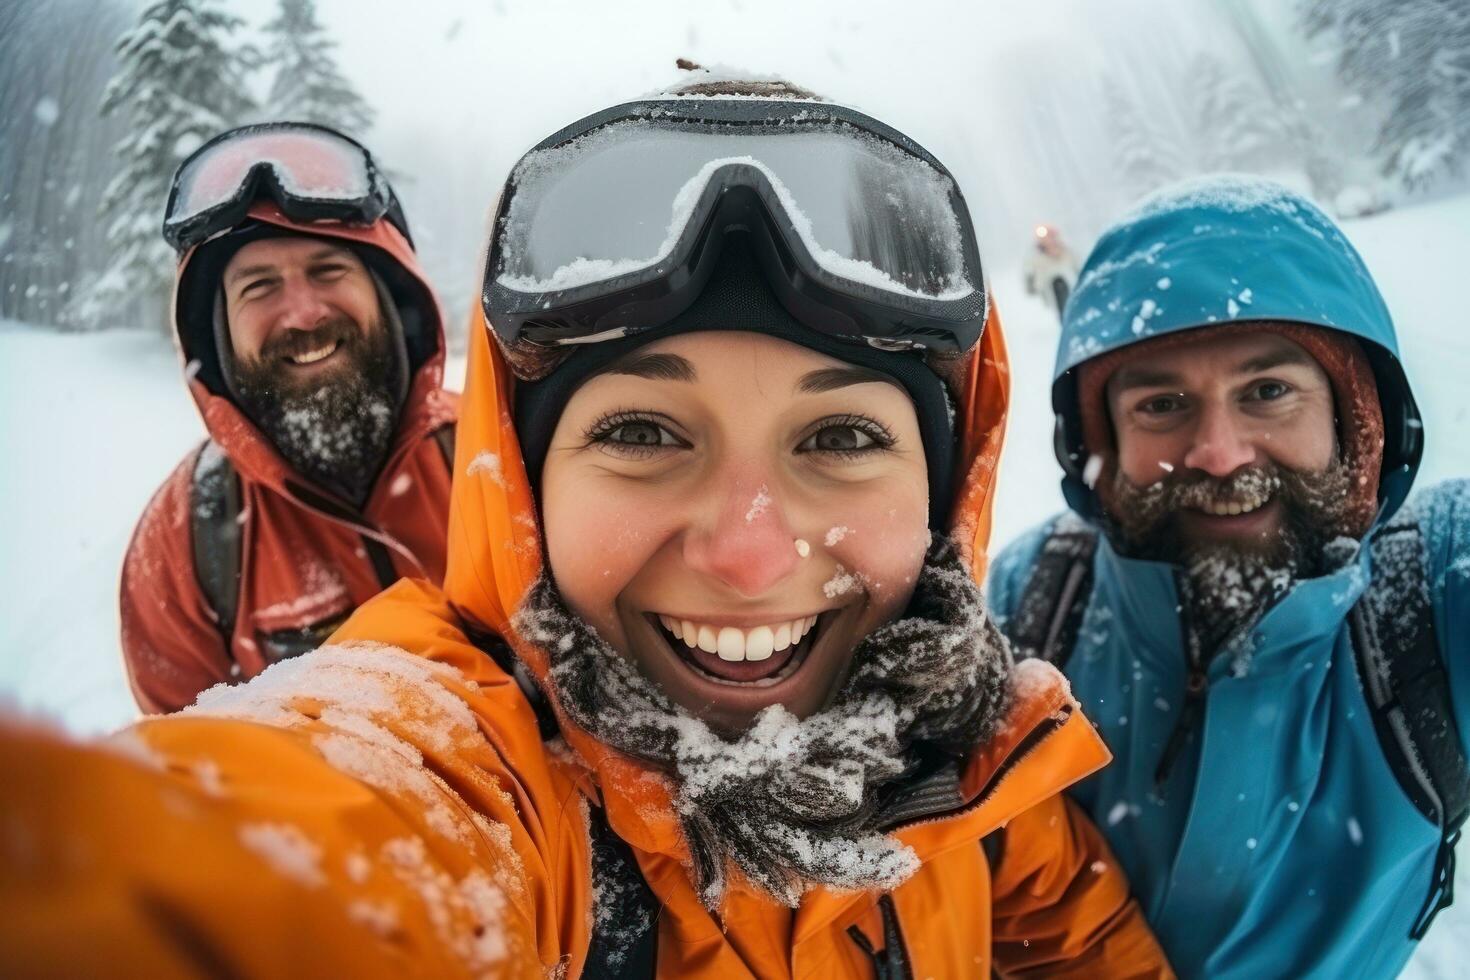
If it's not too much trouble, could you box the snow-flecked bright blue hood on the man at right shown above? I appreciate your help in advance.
[1051,175,1423,520]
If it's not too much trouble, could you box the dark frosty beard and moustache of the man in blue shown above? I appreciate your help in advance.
[1108,458,1352,657]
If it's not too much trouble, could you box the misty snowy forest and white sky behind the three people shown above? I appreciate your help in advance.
[0,0,1470,345]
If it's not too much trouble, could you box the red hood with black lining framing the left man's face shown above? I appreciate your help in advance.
[172,201,453,492]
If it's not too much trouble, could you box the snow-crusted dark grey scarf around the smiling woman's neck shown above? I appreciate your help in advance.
[515,536,1011,908]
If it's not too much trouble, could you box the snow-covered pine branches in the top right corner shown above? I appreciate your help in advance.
[1298,0,1470,190]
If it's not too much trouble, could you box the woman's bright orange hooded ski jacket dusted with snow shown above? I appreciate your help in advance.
[0,302,1172,980]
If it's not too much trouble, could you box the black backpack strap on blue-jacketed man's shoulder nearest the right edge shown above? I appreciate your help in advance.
[1349,519,1470,939]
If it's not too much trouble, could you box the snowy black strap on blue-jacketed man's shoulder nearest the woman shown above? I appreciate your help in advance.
[1005,514,1098,670]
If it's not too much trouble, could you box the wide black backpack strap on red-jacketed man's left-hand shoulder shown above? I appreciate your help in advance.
[190,441,243,651]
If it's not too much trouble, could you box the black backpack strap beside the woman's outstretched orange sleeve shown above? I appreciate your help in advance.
[469,630,660,979]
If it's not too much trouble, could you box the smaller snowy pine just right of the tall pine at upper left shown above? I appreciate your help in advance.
[265,0,375,137]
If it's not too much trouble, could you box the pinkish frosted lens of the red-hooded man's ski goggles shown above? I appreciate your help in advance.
[169,131,373,223]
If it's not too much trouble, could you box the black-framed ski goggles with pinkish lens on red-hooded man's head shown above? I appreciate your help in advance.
[163,122,412,253]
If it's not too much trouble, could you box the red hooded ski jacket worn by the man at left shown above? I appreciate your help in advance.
[121,204,459,711]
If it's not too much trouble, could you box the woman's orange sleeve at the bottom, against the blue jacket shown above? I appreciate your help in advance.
[992,795,1175,977]
